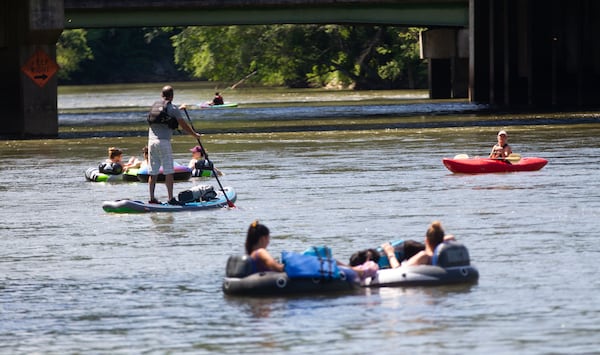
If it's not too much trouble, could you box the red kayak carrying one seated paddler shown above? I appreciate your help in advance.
[442,157,548,174]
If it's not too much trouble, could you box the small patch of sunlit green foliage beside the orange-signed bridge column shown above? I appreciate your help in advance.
[56,29,94,80]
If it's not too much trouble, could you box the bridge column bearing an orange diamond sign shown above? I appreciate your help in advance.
[0,0,64,138]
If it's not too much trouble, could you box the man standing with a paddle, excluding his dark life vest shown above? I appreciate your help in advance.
[148,85,201,205]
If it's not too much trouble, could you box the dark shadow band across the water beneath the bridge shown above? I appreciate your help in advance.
[59,102,600,139]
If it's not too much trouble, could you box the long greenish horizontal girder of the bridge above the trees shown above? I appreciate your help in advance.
[65,0,469,28]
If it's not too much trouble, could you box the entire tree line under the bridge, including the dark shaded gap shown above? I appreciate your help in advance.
[58,25,427,89]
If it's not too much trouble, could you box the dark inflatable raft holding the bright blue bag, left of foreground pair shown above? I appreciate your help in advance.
[222,255,360,296]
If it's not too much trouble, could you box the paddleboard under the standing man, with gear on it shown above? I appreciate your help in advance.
[102,187,237,213]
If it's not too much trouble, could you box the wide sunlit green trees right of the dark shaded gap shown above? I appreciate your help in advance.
[172,25,427,89]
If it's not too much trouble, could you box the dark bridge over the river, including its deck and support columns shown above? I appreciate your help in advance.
[0,0,600,138]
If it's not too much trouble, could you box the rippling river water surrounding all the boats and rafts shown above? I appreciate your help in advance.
[0,84,600,354]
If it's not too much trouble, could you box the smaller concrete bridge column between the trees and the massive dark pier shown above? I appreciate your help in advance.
[421,29,469,99]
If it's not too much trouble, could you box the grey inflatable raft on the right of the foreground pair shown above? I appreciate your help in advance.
[361,242,479,287]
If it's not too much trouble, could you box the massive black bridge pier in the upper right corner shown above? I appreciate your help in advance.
[469,0,600,108]
